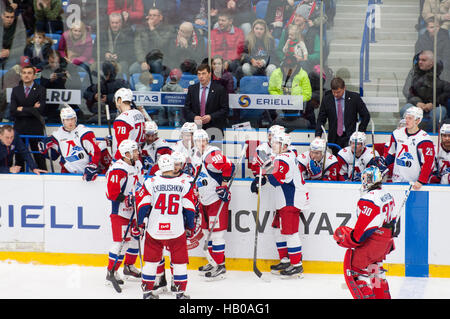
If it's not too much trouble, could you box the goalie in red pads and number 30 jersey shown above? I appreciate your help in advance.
[333,166,399,299]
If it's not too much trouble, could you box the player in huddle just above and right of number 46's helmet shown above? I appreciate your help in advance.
[172,122,201,175]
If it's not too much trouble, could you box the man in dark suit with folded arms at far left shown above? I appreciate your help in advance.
[10,65,47,170]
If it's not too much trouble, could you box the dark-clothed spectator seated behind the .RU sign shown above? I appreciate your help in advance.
[40,50,83,124]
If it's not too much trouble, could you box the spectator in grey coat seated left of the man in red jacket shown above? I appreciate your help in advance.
[168,21,207,67]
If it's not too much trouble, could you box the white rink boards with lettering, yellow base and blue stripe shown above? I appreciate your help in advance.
[0,174,450,277]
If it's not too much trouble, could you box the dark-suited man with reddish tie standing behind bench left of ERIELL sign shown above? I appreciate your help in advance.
[183,64,229,140]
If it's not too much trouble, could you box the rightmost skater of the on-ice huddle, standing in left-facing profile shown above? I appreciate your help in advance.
[268,133,309,278]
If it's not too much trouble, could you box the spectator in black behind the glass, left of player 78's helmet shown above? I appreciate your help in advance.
[83,61,130,118]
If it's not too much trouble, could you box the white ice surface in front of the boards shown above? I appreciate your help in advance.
[0,261,450,300]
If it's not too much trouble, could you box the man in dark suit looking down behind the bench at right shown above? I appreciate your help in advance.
[315,77,370,154]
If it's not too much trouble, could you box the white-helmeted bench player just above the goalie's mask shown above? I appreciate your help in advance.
[337,132,387,182]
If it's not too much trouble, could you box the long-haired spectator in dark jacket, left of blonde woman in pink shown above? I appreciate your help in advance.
[23,30,53,70]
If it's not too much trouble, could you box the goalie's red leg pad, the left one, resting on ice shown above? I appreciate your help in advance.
[344,248,375,299]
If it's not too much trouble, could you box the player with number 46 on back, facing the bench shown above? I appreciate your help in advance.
[136,154,195,299]
